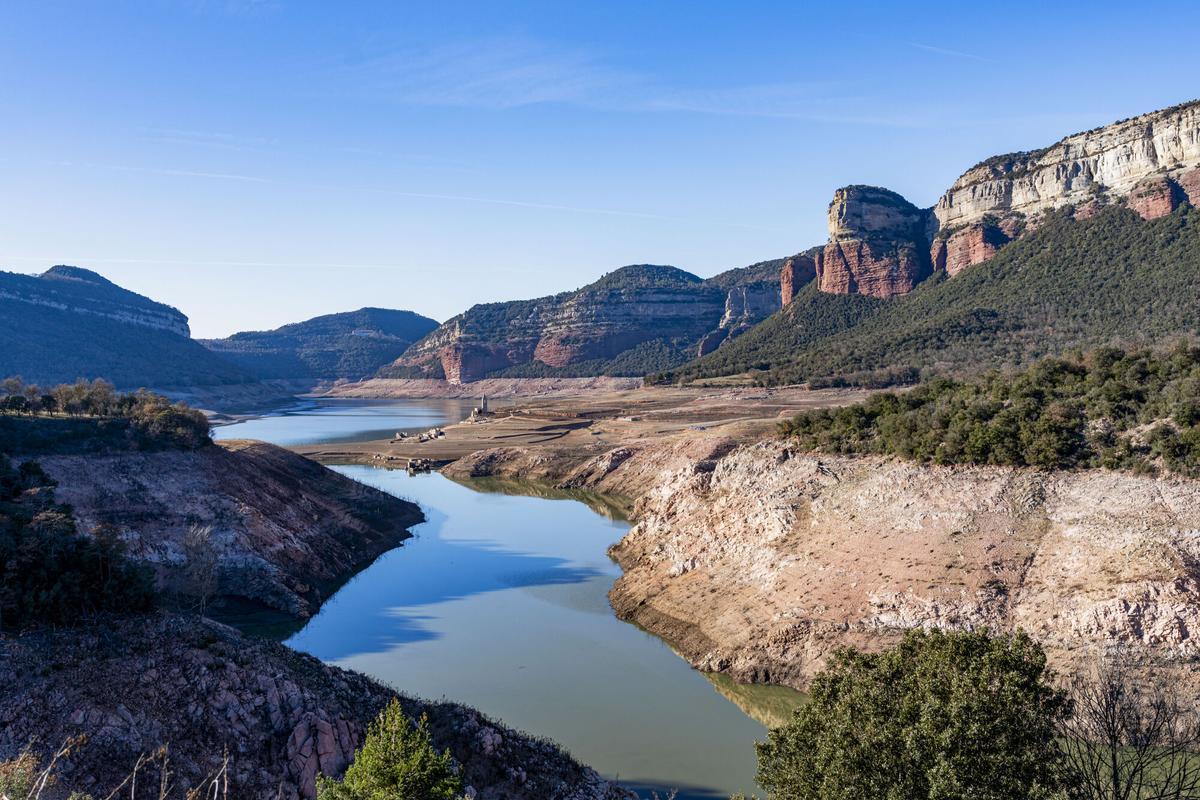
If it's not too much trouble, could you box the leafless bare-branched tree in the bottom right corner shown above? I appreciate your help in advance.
[1061,656,1200,800]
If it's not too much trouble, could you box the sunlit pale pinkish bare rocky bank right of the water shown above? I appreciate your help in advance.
[446,437,1200,691]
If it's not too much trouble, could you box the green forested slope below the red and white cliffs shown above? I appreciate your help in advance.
[662,206,1200,384]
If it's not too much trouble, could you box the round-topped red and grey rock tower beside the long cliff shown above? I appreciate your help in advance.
[816,186,932,297]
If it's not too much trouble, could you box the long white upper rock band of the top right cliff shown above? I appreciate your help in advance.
[934,102,1200,228]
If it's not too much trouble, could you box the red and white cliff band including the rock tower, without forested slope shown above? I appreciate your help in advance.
[801,102,1200,297]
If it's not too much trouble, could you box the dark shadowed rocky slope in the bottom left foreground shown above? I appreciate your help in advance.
[0,614,631,800]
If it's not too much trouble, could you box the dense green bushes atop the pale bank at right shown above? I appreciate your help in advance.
[780,344,1200,476]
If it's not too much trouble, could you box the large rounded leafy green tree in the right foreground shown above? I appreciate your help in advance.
[757,631,1068,800]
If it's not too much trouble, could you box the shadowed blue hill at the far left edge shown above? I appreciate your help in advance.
[0,266,256,393]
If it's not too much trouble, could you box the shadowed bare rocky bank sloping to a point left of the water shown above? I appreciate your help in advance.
[37,441,424,618]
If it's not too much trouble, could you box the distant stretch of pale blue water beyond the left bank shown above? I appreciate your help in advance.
[212,399,473,445]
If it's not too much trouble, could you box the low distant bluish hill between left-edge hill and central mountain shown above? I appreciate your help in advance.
[200,308,438,383]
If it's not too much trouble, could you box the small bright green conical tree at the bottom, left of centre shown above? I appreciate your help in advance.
[317,698,462,800]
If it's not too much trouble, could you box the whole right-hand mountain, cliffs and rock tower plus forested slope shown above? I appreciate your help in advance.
[650,102,1200,385]
